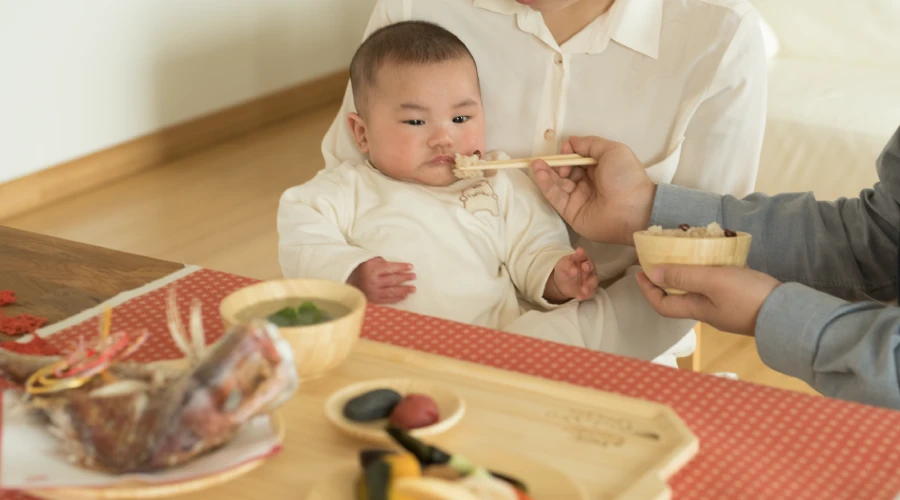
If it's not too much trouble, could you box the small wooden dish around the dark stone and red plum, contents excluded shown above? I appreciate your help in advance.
[325,378,466,444]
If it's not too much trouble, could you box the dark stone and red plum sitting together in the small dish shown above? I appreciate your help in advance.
[343,388,441,430]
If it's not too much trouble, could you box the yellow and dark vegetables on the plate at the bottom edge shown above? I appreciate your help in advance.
[355,426,530,500]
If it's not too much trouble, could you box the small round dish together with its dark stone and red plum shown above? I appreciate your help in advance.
[325,379,465,443]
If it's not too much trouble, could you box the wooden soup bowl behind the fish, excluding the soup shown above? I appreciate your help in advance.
[219,279,366,380]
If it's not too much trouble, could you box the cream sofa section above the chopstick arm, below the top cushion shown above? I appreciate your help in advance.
[756,58,900,200]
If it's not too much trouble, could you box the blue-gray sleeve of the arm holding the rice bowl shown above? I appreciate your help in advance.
[756,283,900,409]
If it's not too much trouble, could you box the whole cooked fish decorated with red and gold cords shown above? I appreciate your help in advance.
[0,295,298,474]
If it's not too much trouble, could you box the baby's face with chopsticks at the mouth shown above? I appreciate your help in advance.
[351,59,485,186]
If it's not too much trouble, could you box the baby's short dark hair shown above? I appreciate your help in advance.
[350,21,475,113]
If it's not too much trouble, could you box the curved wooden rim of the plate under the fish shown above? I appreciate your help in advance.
[26,412,285,500]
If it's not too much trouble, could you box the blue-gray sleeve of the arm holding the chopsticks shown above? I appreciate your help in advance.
[651,125,900,300]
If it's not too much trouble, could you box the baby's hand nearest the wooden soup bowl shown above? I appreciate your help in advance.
[347,257,416,304]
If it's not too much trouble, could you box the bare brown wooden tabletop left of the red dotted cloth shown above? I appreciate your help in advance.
[0,226,184,340]
